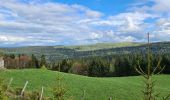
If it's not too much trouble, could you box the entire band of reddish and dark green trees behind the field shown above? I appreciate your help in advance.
[4,54,170,77]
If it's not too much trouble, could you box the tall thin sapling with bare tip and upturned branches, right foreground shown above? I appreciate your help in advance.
[135,33,167,100]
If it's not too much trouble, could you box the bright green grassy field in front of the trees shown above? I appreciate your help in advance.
[0,69,170,100]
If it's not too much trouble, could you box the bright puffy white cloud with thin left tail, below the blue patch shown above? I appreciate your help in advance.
[80,11,156,37]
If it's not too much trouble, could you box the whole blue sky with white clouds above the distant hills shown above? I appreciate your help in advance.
[0,0,170,47]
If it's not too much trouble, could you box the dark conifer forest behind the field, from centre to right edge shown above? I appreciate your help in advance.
[51,54,170,77]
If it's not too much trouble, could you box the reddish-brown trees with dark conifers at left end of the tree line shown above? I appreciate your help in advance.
[4,54,48,69]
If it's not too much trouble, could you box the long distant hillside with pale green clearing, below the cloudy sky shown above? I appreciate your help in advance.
[1,42,170,61]
